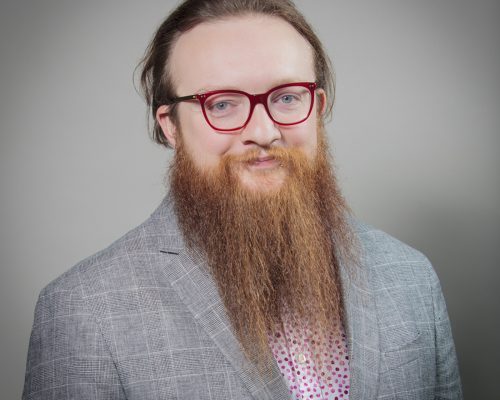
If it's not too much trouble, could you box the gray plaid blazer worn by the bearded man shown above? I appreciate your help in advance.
[23,197,462,400]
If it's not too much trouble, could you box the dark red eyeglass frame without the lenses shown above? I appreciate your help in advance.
[166,82,318,132]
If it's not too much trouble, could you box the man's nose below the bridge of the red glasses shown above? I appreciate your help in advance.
[240,104,281,147]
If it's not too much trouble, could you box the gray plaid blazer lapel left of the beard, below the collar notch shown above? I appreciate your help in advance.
[160,249,290,400]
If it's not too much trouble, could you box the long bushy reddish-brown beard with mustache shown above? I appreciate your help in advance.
[171,133,355,365]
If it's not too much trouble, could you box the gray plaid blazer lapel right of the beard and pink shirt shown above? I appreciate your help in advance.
[341,258,380,400]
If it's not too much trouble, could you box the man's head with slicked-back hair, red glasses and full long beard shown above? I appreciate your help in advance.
[138,0,352,368]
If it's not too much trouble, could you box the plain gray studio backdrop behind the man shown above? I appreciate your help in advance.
[0,0,500,399]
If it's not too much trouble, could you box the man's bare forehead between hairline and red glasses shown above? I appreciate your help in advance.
[170,15,315,95]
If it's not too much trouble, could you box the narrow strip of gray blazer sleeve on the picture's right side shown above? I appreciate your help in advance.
[431,269,463,400]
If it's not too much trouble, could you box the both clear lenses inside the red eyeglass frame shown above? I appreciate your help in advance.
[204,86,312,130]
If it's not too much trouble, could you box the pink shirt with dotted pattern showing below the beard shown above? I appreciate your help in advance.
[269,322,350,400]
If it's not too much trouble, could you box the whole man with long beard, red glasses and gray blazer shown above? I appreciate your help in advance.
[24,0,461,399]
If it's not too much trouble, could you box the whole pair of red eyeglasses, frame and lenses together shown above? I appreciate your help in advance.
[168,82,317,132]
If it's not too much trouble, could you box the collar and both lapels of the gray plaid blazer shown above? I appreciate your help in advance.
[152,196,380,400]
